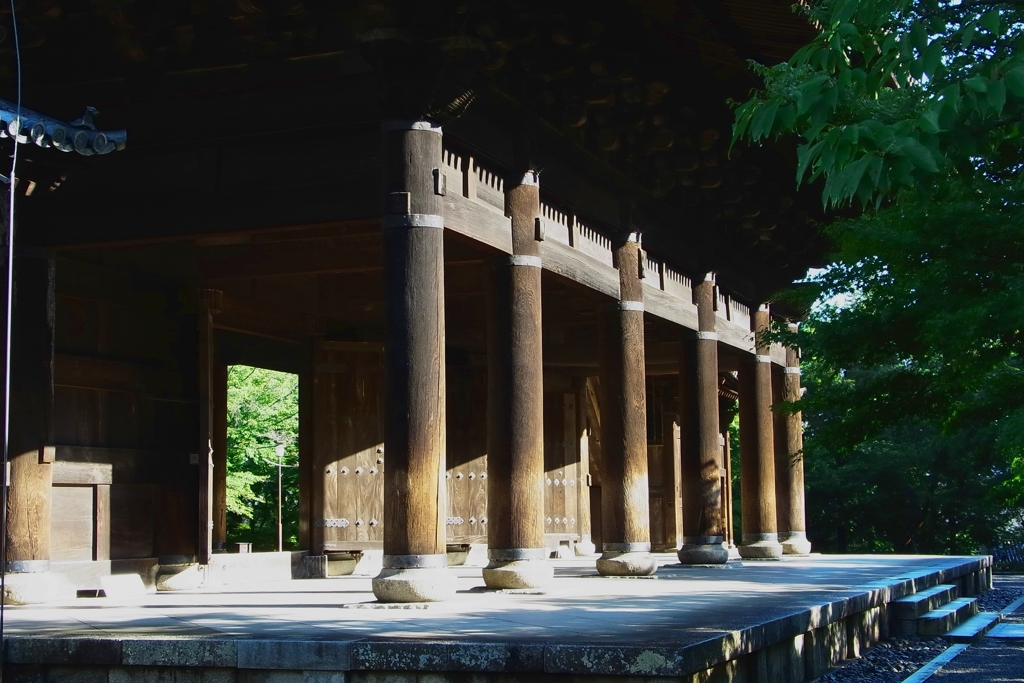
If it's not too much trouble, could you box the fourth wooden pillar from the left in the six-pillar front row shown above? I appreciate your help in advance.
[678,273,729,564]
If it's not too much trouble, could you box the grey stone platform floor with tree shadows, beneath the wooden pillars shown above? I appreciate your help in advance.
[5,554,988,675]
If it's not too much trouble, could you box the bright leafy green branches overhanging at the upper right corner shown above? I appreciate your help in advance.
[733,0,1024,206]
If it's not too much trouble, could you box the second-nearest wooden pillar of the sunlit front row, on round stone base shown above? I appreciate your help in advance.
[483,170,554,589]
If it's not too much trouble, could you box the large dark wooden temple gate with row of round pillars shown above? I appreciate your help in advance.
[4,0,823,600]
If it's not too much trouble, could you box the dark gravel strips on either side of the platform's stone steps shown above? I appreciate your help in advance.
[818,574,1024,683]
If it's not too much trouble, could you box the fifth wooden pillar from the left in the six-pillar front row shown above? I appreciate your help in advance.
[739,305,782,559]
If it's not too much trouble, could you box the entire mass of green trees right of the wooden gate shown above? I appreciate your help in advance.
[733,0,1024,552]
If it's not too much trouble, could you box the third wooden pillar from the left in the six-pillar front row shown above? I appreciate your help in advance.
[597,232,657,577]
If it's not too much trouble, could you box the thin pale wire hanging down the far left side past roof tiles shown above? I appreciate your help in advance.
[0,0,22,647]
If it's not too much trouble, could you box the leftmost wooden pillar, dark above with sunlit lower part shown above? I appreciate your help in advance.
[4,254,54,577]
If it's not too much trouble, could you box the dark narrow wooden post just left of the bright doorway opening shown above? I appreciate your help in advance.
[196,290,221,564]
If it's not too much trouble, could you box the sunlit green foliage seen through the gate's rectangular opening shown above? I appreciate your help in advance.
[227,366,299,550]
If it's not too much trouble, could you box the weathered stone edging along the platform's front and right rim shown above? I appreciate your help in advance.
[3,556,991,676]
